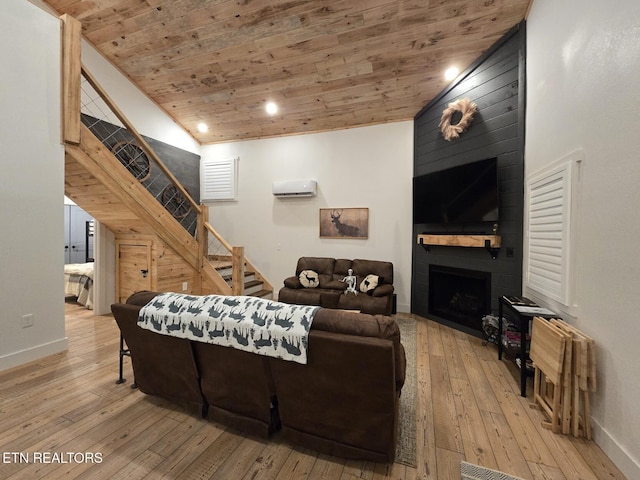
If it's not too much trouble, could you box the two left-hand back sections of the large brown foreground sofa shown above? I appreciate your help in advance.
[111,291,277,437]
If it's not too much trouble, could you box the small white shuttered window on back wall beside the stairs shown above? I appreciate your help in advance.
[200,155,238,202]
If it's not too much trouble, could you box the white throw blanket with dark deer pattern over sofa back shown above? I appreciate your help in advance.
[138,293,320,364]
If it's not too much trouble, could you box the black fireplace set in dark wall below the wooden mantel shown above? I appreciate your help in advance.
[429,265,491,331]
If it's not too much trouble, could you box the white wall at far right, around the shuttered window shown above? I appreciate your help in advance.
[525,0,640,479]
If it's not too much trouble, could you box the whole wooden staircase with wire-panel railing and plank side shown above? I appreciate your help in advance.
[62,16,273,298]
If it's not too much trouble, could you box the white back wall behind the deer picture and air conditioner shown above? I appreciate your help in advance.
[201,121,413,311]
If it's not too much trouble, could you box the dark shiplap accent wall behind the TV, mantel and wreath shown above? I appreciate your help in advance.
[411,23,525,330]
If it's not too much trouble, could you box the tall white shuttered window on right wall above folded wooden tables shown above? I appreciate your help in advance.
[526,154,581,306]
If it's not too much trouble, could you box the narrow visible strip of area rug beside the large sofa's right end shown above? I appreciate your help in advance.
[395,315,417,467]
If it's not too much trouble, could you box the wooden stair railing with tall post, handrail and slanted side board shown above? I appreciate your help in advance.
[61,15,273,296]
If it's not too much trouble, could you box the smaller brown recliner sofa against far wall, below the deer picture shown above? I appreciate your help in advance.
[278,257,394,315]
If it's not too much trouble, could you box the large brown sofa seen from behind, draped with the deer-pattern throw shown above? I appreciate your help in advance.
[111,292,406,462]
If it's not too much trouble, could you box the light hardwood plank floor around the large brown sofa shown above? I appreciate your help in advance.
[0,304,624,480]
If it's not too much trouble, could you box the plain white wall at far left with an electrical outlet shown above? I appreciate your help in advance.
[0,0,67,370]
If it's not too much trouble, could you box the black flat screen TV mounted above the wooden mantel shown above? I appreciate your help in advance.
[413,158,498,224]
